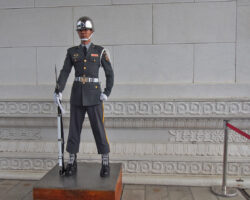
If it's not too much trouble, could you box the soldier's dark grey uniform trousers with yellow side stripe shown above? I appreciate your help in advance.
[66,103,110,154]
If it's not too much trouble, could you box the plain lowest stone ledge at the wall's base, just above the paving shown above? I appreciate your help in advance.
[0,164,250,188]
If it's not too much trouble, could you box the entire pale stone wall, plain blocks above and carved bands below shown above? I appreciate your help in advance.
[0,0,250,185]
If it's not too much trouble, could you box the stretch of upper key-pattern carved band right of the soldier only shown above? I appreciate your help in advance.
[105,101,250,116]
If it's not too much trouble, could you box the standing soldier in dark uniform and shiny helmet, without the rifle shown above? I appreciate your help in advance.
[54,17,114,177]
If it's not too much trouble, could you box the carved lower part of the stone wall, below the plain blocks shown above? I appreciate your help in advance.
[0,100,250,184]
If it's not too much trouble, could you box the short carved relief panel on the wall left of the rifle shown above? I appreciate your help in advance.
[0,128,41,140]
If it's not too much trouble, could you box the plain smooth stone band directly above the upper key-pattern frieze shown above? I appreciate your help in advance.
[0,83,250,100]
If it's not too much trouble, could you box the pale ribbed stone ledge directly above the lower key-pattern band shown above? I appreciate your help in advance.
[0,141,250,157]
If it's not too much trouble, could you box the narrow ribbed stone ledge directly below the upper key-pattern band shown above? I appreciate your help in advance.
[0,115,250,132]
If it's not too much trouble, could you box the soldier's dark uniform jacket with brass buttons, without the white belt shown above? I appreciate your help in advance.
[57,43,114,106]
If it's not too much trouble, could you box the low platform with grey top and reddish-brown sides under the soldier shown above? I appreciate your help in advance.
[33,163,122,200]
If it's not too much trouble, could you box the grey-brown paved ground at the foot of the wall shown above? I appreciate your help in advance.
[0,180,250,200]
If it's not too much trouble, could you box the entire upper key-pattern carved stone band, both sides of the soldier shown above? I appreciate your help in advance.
[0,100,250,117]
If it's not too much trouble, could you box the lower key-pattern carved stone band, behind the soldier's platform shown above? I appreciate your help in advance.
[0,158,250,176]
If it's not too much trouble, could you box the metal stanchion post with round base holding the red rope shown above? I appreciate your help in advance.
[211,120,237,197]
